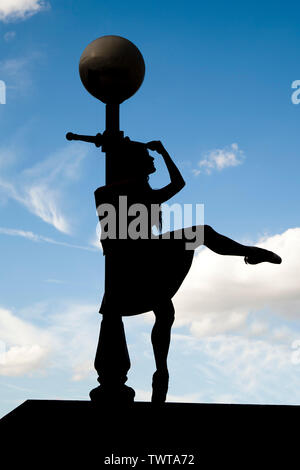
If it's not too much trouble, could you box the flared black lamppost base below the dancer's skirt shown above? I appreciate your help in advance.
[90,314,135,402]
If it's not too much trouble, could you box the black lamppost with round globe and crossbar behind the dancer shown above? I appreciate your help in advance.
[66,36,145,402]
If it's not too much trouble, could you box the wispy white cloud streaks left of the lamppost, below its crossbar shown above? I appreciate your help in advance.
[0,144,89,233]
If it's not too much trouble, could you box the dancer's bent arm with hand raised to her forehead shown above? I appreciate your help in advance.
[146,140,185,203]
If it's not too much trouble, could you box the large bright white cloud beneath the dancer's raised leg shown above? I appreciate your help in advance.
[174,228,300,340]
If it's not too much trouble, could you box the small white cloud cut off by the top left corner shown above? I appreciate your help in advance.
[0,0,49,22]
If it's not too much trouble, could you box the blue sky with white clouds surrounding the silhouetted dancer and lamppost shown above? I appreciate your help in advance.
[0,0,300,416]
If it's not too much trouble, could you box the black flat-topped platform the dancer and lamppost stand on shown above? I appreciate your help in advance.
[0,400,300,469]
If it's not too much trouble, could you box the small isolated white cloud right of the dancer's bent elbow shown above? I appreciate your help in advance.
[192,143,245,176]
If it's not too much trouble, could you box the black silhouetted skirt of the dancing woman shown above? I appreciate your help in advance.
[99,232,194,316]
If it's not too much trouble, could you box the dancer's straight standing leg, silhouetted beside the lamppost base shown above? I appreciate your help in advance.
[151,299,174,403]
